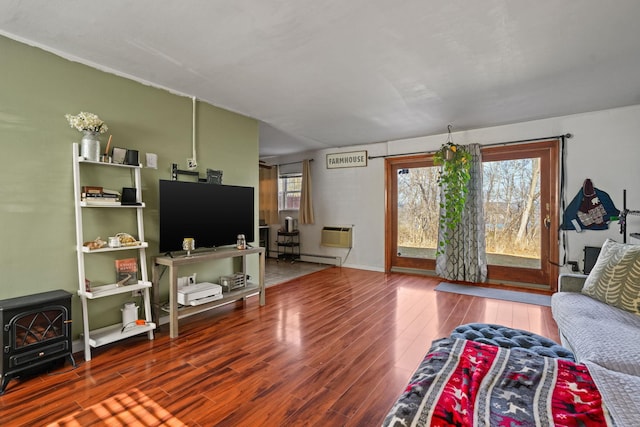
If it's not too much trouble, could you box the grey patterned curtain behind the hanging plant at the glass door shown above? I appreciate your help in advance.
[436,144,487,282]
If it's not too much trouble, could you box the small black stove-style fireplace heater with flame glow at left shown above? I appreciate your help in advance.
[0,290,76,394]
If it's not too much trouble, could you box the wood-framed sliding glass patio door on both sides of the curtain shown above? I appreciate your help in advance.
[386,140,559,288]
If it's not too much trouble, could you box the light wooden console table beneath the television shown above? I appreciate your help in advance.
[151,247,265,338]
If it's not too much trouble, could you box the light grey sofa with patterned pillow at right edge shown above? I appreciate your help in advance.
[551,240,640,426]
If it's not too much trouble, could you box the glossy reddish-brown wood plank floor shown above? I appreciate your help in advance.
[0,267,558,426]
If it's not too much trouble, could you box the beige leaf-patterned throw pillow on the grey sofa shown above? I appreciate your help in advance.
[582,239,640,315]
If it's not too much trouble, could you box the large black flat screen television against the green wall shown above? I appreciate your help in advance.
[159,180,255,253]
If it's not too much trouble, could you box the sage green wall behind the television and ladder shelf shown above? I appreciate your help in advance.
[0,36,258,338]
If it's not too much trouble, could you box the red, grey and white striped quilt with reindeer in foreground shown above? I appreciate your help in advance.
[383,338,614,427]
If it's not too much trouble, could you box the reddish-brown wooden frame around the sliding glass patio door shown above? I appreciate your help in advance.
[385,139,561,291]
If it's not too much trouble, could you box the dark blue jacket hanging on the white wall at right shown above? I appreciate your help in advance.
[560,178,620,232]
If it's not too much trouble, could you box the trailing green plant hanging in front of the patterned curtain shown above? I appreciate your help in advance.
[433,140,471,255]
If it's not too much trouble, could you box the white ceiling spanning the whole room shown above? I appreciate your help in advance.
[0,0,640,158]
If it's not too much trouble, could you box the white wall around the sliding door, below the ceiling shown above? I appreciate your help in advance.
[270,105,640,271]
